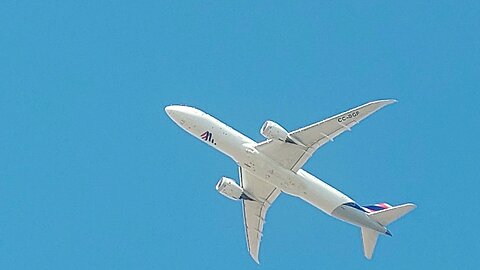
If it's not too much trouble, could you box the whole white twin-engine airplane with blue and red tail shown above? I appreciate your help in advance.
[165,99,416,264]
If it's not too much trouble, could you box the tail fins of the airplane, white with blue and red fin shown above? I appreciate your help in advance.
[362,203,417,259]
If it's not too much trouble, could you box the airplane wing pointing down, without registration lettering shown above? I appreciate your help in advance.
[239,167,280,263]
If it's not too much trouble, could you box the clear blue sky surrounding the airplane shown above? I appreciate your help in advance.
[0,0,480,269]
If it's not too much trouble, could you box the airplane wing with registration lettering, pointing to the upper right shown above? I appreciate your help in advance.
[256,99,396,172]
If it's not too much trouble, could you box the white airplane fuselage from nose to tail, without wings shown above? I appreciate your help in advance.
[165,105,390,235]
